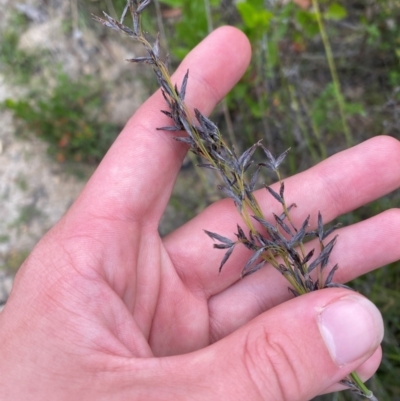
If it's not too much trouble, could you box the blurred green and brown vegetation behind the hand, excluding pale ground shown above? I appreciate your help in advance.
[0,0,400,401]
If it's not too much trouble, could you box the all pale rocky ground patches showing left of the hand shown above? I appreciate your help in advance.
[0,0,197,310]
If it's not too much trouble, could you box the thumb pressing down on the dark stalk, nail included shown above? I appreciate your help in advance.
[174,289,383,401]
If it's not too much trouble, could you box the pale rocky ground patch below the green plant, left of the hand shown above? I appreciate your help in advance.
[0,85,92,307]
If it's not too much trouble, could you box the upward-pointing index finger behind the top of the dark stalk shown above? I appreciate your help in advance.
[68,27,251,228]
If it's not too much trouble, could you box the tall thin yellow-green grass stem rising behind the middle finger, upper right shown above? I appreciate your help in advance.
[312,0,354,147]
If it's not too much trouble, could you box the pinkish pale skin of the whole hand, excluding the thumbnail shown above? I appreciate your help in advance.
[0,27,400,401]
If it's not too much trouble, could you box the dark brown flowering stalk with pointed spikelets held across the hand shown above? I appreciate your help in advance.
[93,0,376,400]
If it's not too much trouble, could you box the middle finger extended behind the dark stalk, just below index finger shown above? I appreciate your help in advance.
[164,136,400,297]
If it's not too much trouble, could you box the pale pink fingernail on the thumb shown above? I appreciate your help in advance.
[318,295,383,366]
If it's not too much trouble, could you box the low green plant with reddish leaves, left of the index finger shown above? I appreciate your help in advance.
[3,74,118,163]
